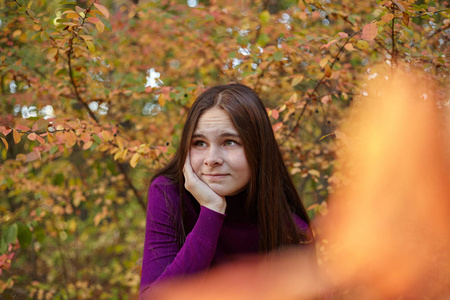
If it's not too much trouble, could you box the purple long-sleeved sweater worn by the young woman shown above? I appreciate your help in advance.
[140,176,308,296]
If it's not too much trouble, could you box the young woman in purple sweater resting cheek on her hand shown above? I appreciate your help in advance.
[140,84,314,296]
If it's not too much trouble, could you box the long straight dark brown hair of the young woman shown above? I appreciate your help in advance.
[153,84,313,252]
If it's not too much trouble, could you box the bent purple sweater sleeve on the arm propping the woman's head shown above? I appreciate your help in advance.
[140,177,225,297]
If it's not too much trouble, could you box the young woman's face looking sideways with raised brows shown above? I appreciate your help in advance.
[189,107,251,196]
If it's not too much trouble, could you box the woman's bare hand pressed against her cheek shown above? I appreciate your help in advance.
[183,153,227,214]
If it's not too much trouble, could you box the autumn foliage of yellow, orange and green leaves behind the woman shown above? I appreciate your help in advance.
[0,0,450,299]
